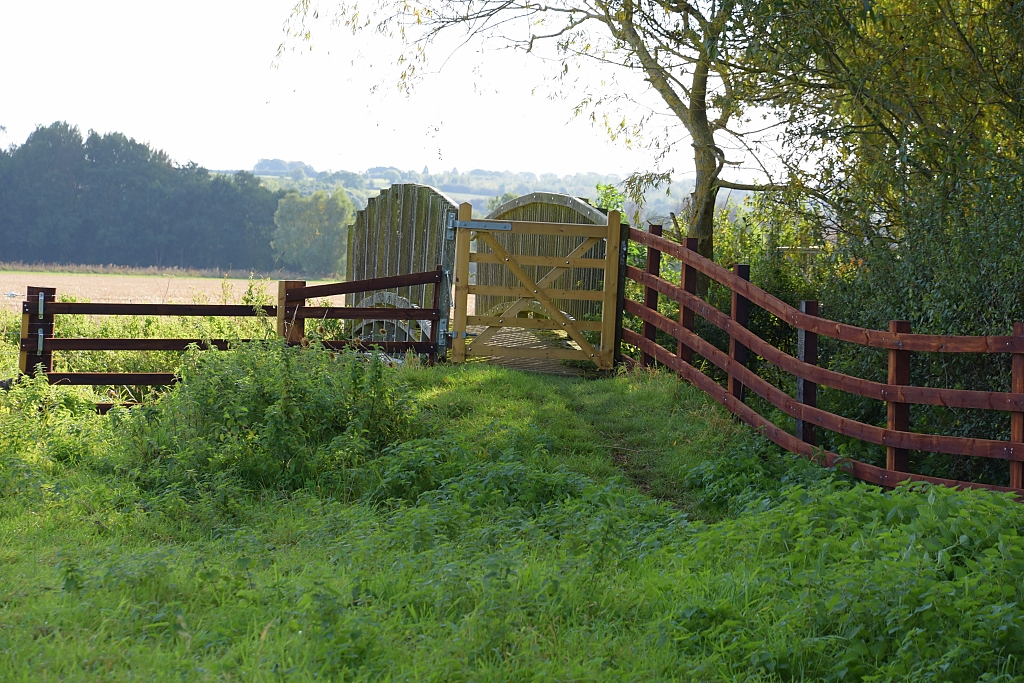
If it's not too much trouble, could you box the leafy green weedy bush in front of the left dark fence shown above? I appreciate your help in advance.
[113,341,415,490]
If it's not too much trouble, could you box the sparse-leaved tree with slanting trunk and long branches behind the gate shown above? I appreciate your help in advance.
[288,0,778,266]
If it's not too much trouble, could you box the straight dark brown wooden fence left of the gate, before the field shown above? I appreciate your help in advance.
[19,266,447,410]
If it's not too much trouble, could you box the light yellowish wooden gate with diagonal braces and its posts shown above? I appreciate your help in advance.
[452,204,621,370]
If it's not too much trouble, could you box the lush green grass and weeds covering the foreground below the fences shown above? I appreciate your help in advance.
[0,344,1024,681]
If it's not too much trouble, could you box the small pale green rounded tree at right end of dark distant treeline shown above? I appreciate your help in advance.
[270,190,355,275]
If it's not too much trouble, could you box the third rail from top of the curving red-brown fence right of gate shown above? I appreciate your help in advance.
[624,301,1024,461]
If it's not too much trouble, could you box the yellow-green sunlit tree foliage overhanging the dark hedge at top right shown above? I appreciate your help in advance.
[745,0,1024,241]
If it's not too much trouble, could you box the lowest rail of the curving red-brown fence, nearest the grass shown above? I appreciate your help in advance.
[623,330,1024,500]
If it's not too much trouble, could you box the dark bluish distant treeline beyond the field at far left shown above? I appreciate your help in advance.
[0,122,284,272]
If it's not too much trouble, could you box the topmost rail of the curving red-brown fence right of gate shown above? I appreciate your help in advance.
[630,228,1024,353]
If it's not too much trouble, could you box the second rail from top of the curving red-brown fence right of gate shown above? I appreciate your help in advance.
[627,266,1024,411]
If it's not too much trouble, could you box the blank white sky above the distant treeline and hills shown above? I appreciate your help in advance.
[0,0,692,178]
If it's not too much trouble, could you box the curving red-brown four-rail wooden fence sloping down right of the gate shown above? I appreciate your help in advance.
[622,229,1024,494]
